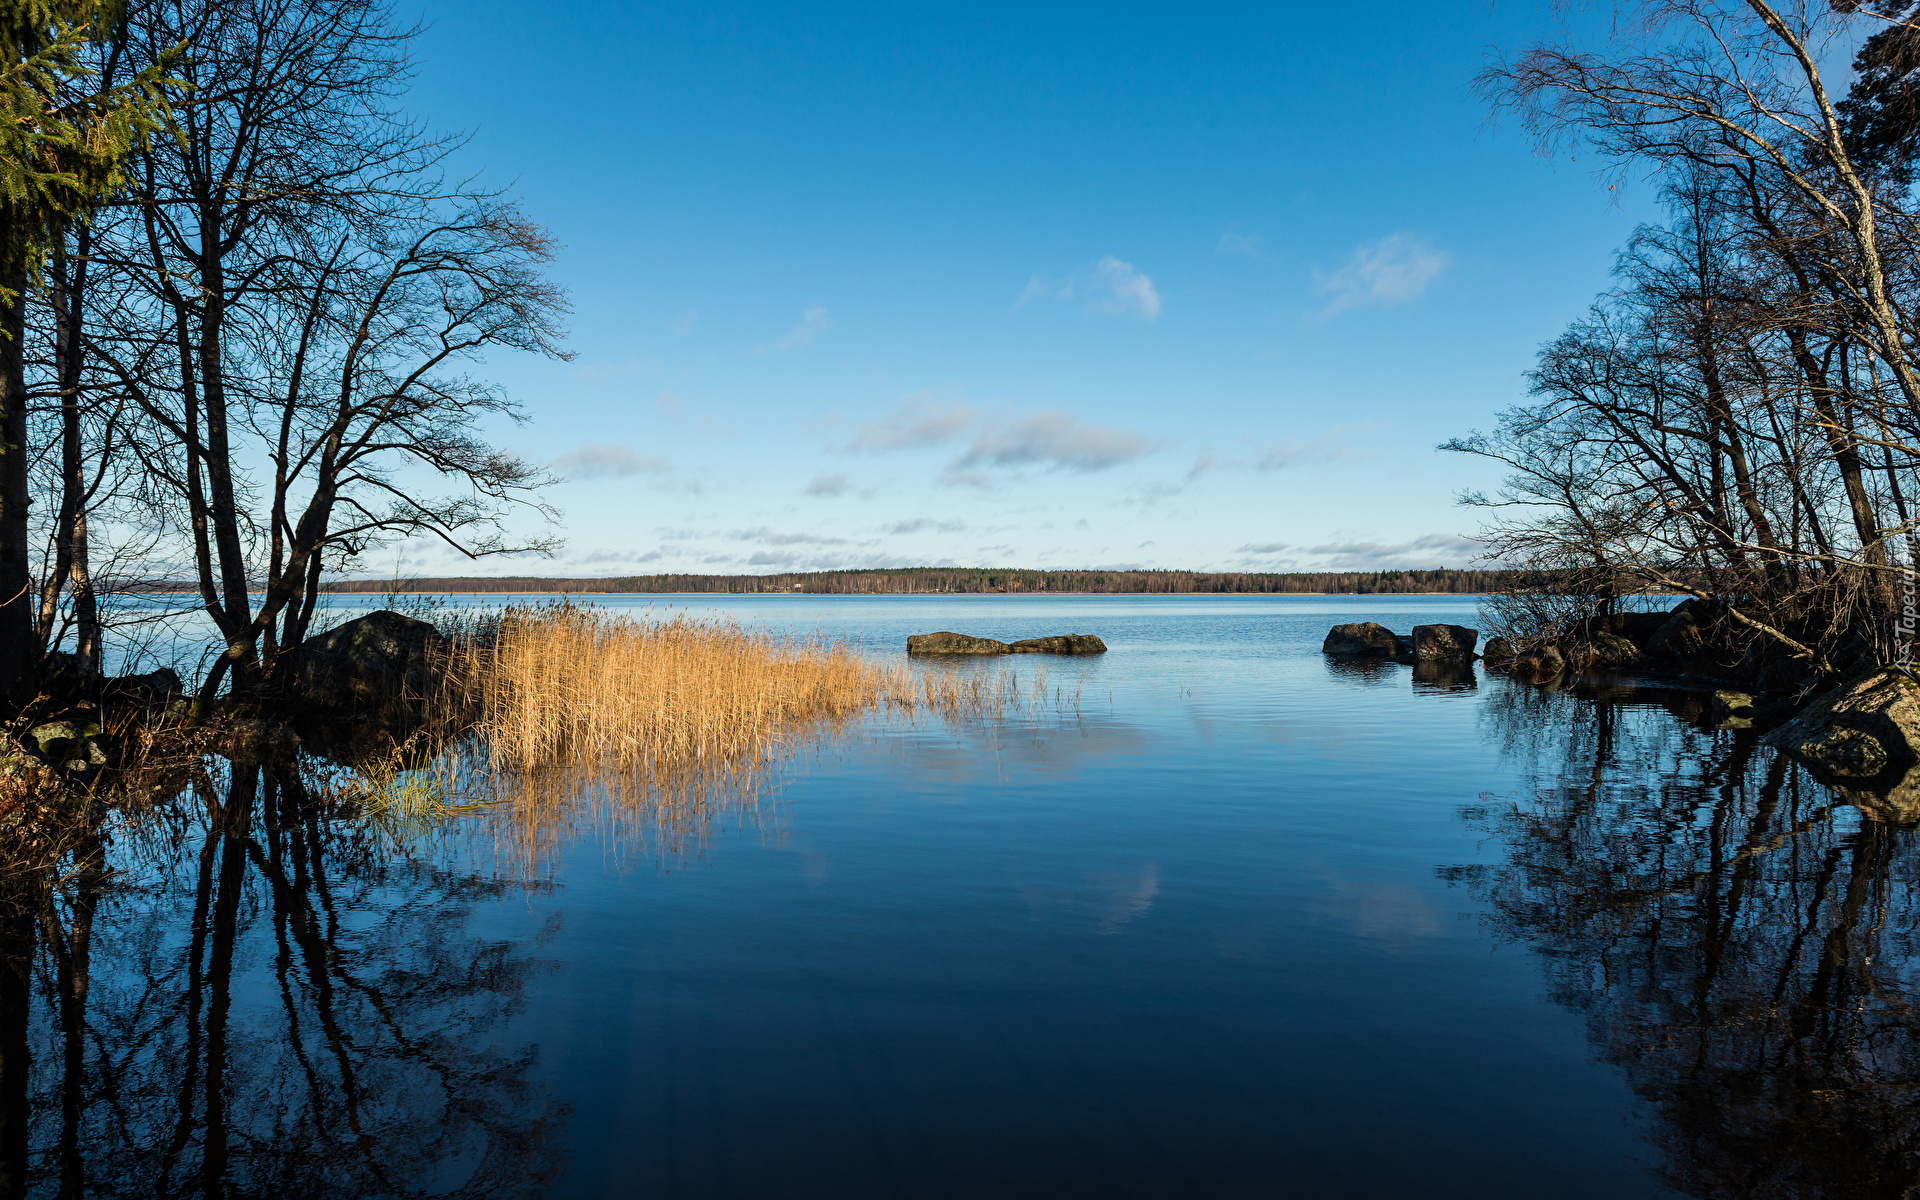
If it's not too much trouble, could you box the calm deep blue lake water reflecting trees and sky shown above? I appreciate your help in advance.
[18,595,1920,1200]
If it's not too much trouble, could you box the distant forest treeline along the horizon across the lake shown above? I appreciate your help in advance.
[326,566,1534,595]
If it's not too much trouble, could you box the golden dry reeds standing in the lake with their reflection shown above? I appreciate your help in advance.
[422,601,1018,858]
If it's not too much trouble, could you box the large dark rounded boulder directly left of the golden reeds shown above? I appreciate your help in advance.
[288,609,449,712]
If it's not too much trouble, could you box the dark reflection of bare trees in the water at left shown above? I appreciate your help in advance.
[0,766,566,1198]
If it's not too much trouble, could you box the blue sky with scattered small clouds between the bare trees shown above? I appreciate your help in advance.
[393,0,1653,574]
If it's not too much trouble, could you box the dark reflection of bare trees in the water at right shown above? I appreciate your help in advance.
[1442,685,1920,1198]
